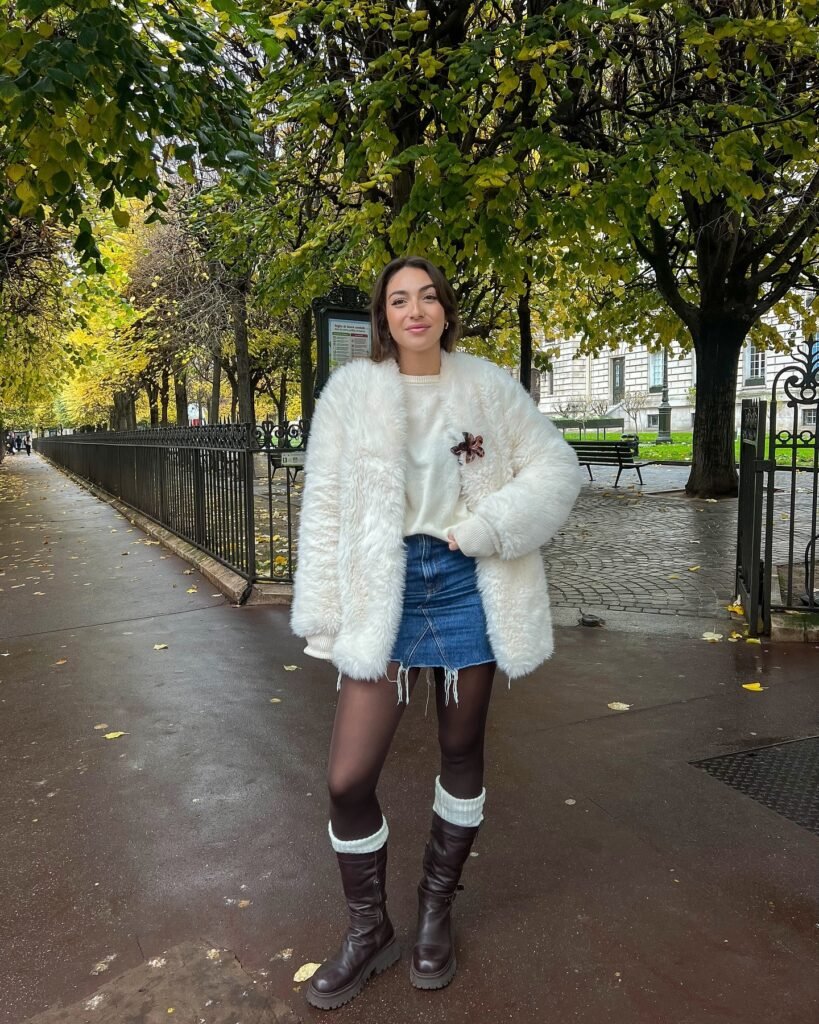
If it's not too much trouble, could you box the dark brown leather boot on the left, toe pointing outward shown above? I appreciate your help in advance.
[307,846,401,1010]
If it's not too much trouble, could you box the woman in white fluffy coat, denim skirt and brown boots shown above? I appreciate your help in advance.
[292,258,580,1010]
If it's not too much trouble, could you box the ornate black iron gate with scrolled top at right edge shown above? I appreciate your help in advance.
[736,338,819,636]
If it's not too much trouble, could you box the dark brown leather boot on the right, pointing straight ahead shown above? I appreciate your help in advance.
[410,814,478,988]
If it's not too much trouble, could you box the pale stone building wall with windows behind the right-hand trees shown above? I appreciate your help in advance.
[541,319,815,431]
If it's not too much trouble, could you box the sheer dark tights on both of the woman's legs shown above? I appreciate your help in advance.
[328,663,494,840]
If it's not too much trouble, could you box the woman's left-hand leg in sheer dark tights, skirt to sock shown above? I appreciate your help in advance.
[328,663,418,841]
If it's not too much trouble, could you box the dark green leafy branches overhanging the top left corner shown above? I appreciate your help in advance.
[0,0,253,272]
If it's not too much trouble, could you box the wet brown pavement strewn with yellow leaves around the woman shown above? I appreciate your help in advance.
[0,456,819,1024]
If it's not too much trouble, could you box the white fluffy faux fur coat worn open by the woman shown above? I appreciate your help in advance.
[291,352,581,679]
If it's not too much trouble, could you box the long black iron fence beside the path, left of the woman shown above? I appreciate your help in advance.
[35,421,307,583]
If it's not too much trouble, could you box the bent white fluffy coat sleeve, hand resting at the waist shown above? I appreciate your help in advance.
[466,373,583,559]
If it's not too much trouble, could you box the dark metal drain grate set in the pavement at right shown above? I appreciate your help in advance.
[692,736,819,836]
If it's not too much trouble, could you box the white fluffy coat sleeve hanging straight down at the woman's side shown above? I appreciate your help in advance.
[290,379,344,643]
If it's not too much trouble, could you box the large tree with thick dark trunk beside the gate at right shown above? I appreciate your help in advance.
[552,0,819,497]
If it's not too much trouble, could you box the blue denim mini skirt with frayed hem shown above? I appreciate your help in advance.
[390,534,495,703]
